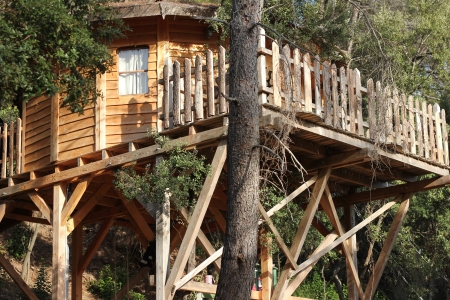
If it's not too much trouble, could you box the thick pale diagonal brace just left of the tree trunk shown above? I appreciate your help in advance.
[166,139,227,300]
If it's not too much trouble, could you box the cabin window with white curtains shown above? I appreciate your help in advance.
[119,48,148,95]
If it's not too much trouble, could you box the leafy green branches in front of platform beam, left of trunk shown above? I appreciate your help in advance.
[114,135,211,208]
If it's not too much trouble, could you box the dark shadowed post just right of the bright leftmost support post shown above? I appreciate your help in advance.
[71,226,83,300]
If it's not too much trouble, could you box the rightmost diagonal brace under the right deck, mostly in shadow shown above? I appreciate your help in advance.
[361,193,412,299]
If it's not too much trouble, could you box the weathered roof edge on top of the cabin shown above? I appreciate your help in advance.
[112,0,218,19]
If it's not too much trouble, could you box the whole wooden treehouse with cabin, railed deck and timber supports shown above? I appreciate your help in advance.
[0,2,450,300]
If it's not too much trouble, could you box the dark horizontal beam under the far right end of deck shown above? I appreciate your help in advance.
[334,175,450,207]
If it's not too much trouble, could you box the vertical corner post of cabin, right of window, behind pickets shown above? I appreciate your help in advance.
[156,18,169,132]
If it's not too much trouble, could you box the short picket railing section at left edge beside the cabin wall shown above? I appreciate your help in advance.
[0,118,23,179]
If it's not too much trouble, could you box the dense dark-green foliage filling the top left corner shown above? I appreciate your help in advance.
[0,0,123,113]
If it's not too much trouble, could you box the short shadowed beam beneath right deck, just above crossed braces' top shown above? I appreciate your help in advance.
[303,148,373,173]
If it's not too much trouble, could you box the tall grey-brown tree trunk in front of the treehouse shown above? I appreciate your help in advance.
[216,0,261,300]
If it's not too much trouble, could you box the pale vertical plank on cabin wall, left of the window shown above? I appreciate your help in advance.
[94,74,106,150]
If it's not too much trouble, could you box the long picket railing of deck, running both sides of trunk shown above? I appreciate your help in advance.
[160,29,449,165]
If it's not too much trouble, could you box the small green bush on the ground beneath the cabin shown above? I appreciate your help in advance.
[89,265,145,300]
